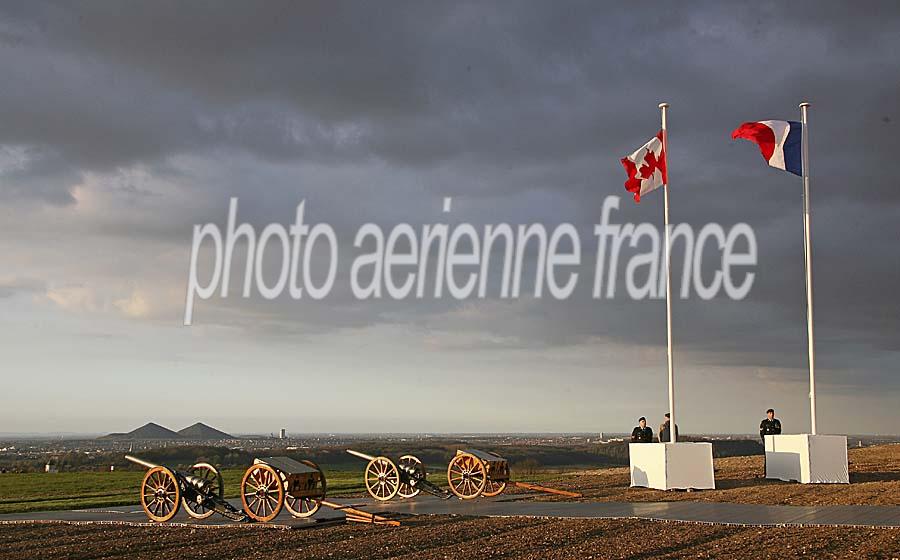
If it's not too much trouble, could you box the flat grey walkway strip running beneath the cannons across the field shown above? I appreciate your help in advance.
[0,494,900,529]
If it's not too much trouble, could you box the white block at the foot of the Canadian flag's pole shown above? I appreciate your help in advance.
[628,442,716,490]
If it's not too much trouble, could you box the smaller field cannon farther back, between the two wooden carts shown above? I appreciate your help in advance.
[347,449,450,501]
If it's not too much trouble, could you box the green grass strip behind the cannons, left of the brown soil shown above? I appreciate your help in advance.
[0,468,559,514]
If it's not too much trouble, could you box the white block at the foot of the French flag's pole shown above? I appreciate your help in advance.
[766,434,850,484]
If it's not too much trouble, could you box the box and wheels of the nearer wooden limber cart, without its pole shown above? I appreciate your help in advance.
[241,457,326,522]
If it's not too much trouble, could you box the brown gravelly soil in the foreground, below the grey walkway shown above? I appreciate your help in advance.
[0,517,900,560]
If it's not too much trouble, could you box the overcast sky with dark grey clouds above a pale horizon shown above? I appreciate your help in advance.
[0,1,900,433]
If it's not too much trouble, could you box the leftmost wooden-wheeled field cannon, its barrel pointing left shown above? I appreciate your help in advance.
[125,455,248,523]
